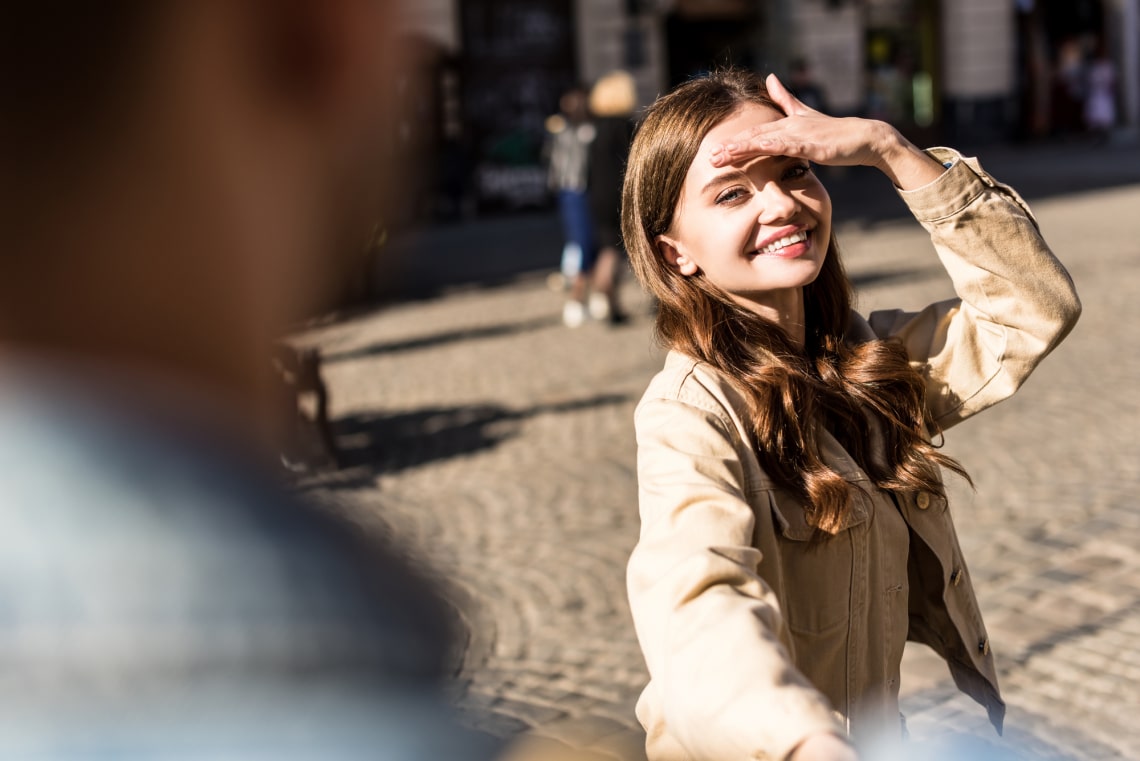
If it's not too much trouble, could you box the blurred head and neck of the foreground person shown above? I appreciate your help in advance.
[0,0,401,419]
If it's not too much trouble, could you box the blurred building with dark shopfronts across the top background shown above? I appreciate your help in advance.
[398,0,1140,219]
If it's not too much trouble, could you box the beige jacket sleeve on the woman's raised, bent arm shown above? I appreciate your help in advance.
[869,148,1081,429]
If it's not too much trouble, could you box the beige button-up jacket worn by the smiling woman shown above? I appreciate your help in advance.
[628,149,1081,761]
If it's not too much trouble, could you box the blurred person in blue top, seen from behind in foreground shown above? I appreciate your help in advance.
[0,0,499,761]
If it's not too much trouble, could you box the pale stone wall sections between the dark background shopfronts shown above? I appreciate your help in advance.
[404,0,1140,134]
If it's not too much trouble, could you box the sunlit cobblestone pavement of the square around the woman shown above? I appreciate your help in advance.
[301,176,1140,759]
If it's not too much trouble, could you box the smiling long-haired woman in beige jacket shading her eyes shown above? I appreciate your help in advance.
[622,72,1080,761]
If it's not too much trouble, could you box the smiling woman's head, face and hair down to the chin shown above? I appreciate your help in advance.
[622,71,846,341]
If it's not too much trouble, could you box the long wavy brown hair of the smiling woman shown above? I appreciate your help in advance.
[621,69,969,534]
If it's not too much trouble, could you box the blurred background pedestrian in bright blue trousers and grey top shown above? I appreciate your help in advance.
[546,87,597,328]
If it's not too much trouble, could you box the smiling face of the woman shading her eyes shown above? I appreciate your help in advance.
[657,104,831,321]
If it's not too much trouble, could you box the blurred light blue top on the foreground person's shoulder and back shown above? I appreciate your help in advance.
[0,362,492,761]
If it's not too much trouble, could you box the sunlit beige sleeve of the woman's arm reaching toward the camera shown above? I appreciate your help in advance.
[627,391,845,760]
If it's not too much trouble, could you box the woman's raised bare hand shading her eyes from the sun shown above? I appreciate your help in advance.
[713,74,943,190]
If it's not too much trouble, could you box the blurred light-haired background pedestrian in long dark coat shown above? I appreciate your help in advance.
[587,69,637,325]
